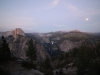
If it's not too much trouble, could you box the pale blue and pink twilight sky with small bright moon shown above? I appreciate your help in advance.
[0,0,100,33]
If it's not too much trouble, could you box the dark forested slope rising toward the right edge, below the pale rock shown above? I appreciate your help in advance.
[53,43,100,75]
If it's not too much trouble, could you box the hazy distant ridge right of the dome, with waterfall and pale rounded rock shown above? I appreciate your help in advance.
[26,30,100,57]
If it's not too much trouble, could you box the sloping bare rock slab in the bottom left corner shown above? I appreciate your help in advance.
[0,61,44,75]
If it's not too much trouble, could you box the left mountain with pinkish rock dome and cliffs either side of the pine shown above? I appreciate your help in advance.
[0,28,50,62]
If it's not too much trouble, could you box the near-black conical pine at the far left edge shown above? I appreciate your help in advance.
[0,36,11,61]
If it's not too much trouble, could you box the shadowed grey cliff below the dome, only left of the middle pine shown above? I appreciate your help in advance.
[8,35,29,59]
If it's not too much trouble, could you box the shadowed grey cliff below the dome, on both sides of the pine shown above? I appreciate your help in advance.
[9,35,49,62]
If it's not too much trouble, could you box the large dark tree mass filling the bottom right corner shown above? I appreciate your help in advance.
[74,44,100,75]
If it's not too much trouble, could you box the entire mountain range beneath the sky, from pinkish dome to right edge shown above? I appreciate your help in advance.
[0,28,100,60]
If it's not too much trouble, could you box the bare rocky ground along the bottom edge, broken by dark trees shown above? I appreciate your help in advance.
[0,61,77,75]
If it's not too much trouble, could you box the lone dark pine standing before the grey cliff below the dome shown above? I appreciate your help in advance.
[26,39,37,63]
